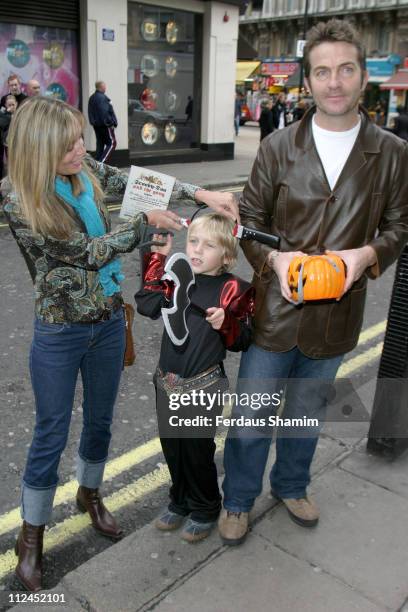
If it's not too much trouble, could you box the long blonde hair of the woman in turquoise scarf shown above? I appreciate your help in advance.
[8,97,103,239]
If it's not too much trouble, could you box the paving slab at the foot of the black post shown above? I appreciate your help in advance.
[340,440,408,499]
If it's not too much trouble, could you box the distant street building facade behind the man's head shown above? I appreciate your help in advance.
[240,0,408,117]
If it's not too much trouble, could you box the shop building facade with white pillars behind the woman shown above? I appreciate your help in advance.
[0,0,240,165]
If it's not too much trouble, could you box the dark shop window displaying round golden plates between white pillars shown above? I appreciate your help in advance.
[128,2,199,154]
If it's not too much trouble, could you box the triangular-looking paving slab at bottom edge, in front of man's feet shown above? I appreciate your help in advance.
[154,532,387,612]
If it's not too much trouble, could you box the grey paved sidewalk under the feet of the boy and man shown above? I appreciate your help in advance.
[13,406,408,612]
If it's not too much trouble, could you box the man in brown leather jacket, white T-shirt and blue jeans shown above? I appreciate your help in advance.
[219,19,408,545]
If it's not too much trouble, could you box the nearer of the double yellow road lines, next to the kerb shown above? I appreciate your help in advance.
[0,436,225,580]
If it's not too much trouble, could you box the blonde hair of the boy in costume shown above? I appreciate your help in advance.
[187,213,238,274]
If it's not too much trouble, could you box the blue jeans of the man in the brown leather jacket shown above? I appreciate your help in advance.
[223,345,343,512]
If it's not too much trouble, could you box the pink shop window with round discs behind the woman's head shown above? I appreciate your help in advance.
[0,23,79,107]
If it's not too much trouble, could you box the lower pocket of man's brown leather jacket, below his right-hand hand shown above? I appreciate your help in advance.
[326,285,366,344]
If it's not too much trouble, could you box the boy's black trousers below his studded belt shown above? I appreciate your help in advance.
[156,378,228,523]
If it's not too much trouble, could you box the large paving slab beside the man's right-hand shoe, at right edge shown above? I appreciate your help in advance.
[253,468,408,610]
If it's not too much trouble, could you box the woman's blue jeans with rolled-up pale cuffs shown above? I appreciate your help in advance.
[22,308,125,525]
